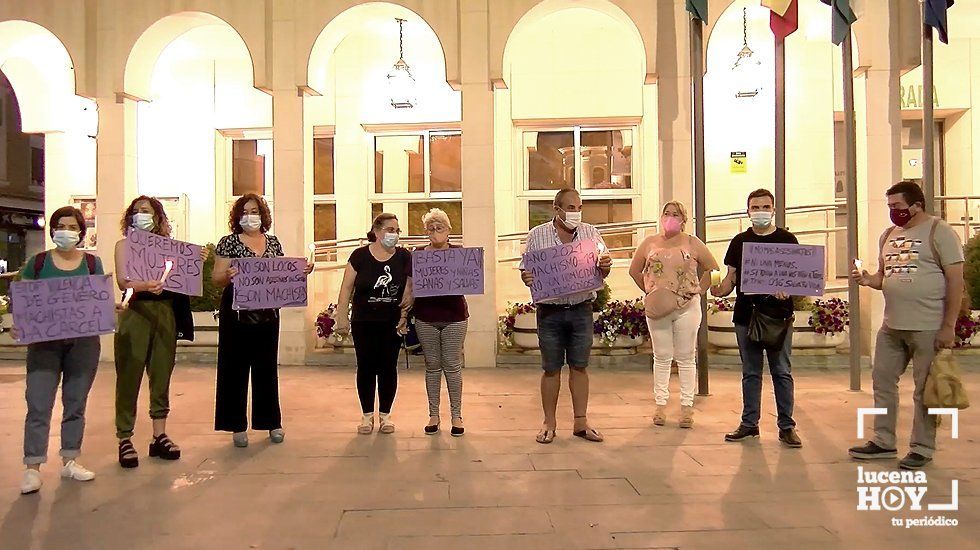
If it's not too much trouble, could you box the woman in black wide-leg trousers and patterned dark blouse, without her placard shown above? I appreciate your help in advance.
[211,193,313,447]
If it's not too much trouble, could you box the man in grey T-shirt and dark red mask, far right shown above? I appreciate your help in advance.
[848,181,963,470]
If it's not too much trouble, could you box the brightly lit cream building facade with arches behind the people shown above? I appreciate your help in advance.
[0,0,980,366]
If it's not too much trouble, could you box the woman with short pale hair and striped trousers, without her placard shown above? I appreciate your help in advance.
[412,208,469,437]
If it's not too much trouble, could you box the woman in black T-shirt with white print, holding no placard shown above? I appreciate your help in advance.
[334,214,412,434]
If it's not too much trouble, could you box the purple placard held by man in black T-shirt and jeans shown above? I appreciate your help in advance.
[740,243,827,296]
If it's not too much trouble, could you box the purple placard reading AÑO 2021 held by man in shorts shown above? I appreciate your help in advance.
[524,241,602,303]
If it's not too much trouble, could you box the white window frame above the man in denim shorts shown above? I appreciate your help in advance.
[515,122,642,231]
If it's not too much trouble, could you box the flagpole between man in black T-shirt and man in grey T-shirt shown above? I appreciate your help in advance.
[841,29,861,391]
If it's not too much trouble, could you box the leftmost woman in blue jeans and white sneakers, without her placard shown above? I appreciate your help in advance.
[14,206,104,495]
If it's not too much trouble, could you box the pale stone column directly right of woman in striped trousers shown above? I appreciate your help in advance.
[459,0,497,367]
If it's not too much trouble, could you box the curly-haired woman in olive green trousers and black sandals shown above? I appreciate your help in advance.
[115,196,199,468]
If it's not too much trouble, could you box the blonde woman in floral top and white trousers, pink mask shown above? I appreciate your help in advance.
[630,202,718,428]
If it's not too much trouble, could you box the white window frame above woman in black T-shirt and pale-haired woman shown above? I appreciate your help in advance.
[365,123,463,237]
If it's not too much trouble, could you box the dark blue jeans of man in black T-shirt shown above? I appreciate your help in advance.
[735,325,796,430]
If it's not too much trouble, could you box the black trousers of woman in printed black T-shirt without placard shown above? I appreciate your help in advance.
[350,321,402,414]
